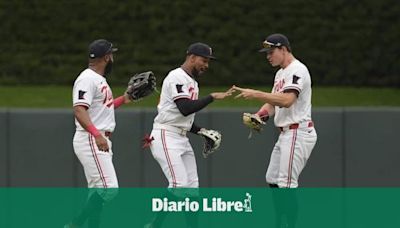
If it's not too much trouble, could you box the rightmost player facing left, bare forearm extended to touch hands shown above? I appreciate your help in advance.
[233,34,317,188]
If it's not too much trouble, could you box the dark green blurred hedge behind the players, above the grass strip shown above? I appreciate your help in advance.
[0,0,400,87]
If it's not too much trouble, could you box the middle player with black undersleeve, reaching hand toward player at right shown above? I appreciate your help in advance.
[146,43,231,227]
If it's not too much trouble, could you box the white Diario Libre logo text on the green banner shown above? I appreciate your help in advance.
[152,193,253,212]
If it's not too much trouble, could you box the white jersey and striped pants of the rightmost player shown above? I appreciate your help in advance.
[266,59,317,188]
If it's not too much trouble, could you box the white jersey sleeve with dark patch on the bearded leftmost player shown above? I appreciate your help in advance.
[72,78,95,107]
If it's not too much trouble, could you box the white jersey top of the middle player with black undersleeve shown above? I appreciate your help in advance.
[154,68,199,131]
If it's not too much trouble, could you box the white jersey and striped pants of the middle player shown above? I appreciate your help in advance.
[150,68,199,188]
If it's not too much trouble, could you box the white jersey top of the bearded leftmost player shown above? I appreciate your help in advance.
[72,69,115,132]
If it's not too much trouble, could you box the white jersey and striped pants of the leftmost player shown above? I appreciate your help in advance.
[72,69,118,197]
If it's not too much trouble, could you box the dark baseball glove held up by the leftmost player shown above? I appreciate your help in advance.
[126,71,156,101]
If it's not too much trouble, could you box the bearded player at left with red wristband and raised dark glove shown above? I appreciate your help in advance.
[65,39,130,227]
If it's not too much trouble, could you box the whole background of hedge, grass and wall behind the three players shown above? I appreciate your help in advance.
[0,0,400,187]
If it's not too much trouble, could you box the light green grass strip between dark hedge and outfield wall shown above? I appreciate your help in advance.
[0,86,400,108]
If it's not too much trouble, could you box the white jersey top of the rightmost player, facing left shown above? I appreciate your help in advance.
[272,59,311,127]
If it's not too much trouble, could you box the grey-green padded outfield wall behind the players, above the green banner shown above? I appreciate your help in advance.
[0,108,400,187]
